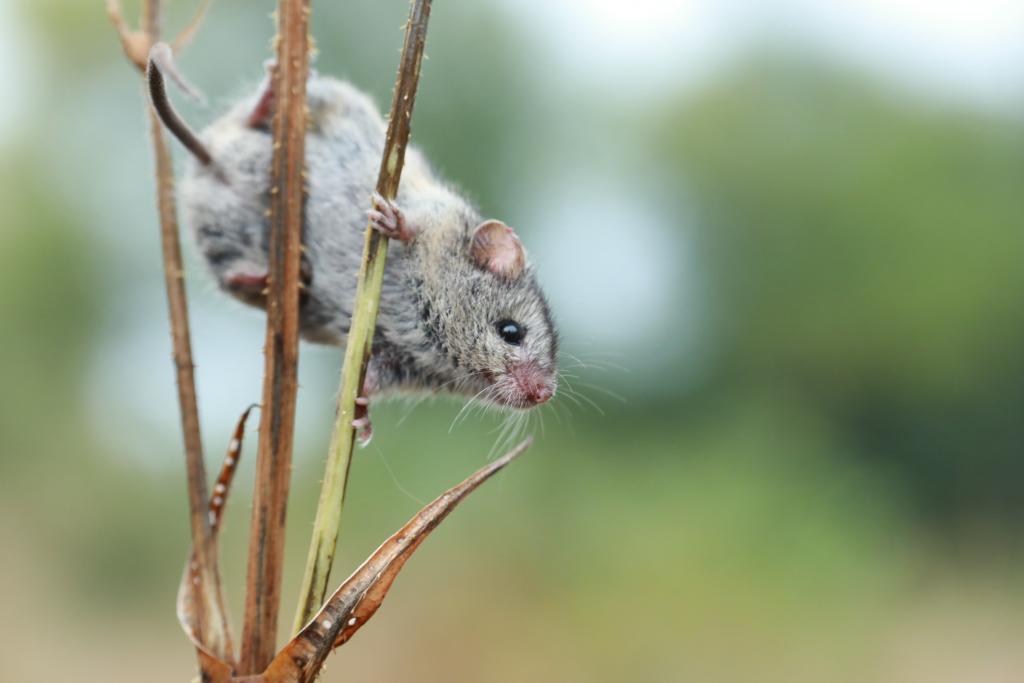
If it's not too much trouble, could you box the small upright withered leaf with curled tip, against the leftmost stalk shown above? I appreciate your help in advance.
[177,405,255,682]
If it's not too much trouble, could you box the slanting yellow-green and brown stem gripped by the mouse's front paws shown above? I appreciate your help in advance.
[294,0,430,633]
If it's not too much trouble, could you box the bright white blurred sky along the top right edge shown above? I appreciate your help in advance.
[502,0,1024,105]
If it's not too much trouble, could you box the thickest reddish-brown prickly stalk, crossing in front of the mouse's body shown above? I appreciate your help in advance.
[240,0,309,674]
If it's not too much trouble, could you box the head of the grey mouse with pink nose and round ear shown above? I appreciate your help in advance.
[438,220,558,409]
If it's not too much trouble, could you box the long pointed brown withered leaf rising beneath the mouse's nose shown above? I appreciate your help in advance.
[258,438,532,683]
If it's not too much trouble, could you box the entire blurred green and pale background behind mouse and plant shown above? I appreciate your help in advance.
[0,0,1024,683]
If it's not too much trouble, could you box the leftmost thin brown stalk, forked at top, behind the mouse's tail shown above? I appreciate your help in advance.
[108,0,230,656]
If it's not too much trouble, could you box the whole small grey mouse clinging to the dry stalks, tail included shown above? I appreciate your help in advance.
[150,46,558,428]
